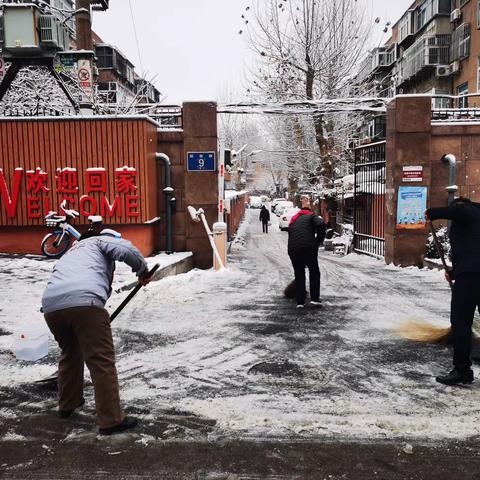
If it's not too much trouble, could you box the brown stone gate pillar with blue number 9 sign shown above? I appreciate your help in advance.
[183,102,218,268]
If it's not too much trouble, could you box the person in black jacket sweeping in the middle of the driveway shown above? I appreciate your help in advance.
[288,197,325,308]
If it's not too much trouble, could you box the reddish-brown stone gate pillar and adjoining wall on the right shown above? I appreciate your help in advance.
[386,96,480,266]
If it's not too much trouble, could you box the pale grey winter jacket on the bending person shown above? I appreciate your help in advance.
[42,236,148,313]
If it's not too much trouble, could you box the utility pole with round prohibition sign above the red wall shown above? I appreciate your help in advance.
[75,0,95,115]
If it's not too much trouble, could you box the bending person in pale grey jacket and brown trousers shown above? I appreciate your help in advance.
[42,229,150,435]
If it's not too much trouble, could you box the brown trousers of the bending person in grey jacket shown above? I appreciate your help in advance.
[45,307,124,428]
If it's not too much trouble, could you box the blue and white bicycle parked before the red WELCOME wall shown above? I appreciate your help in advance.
[41,200,102,258]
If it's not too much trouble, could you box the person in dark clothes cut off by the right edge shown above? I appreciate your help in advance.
[425,198,480,385]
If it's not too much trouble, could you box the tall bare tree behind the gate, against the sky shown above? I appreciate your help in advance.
[244,0,370,186]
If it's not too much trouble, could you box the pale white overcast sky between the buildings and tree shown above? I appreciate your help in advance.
[94,0,412,104]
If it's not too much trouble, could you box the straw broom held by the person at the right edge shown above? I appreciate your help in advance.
[396,220,453,345]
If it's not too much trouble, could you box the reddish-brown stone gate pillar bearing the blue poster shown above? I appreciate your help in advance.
[385,96,432,266]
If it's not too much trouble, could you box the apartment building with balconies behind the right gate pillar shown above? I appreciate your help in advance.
[353,0,480,140]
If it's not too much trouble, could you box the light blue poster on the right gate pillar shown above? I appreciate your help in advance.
[397,187,427,230]
